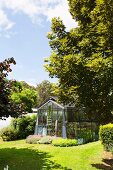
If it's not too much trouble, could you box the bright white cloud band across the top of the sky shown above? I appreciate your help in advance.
[0,0,77,36]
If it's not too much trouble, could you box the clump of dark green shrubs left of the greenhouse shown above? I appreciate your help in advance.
[0,116,36,141]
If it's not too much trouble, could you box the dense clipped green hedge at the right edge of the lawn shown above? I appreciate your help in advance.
[99,124,113,151]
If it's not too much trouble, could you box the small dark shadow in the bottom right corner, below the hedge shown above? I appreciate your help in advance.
[92,159,113,170]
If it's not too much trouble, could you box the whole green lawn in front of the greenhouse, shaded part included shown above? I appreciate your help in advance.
[0,140,110,170]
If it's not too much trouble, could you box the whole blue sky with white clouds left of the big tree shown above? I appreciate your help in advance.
[0,0,77,85]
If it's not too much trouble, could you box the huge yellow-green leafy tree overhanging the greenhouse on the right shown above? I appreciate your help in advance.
[46,0,113,123]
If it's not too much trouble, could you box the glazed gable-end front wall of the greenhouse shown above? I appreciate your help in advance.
[38,102,62,136]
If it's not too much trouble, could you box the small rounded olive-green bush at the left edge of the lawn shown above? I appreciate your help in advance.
[0,127,17,141]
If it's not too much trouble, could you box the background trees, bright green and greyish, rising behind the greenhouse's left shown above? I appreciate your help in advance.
[10,80,56,113]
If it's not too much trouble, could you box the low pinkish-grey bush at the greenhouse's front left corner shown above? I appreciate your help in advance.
[26,135,42,144]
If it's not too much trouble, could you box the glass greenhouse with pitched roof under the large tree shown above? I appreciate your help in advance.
[35,97,98,142]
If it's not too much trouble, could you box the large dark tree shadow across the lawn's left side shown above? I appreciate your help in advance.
[0,148,71,170]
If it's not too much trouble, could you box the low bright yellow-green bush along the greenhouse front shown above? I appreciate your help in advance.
[52,138,77,147]
